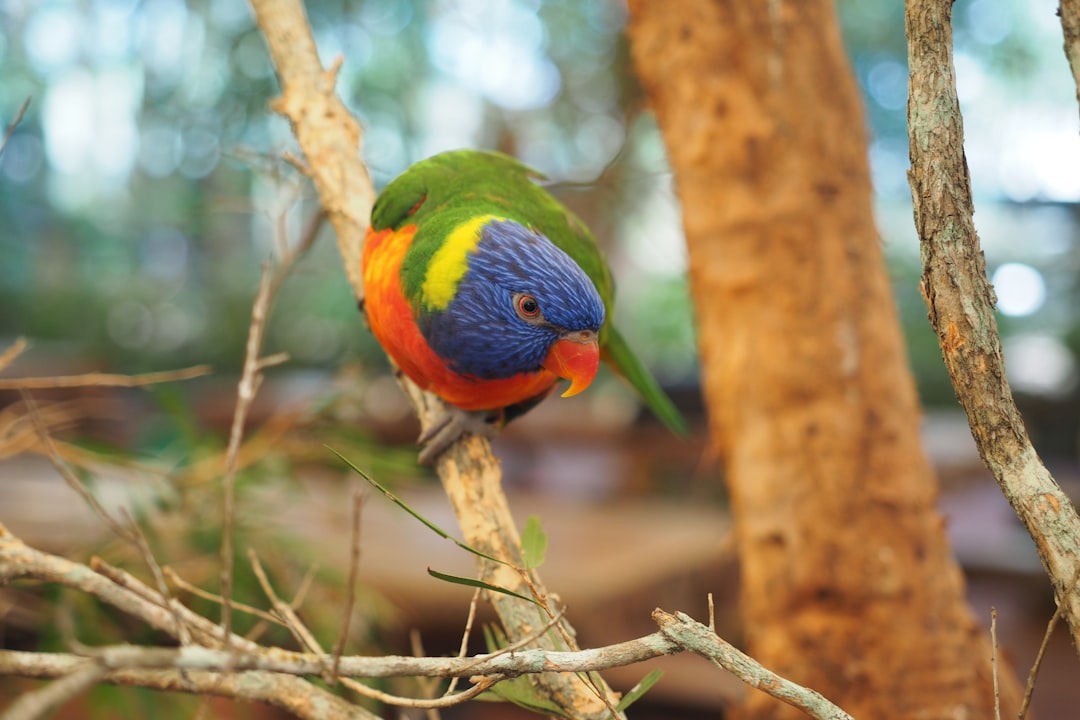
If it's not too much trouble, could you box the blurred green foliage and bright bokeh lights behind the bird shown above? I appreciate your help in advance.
[0,0,1080,440]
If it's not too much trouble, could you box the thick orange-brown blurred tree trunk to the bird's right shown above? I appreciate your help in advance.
[630,0,1018,718]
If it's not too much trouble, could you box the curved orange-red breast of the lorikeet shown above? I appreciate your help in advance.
[363,226,558,410]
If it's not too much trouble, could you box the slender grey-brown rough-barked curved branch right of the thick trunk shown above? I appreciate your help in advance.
[906,0,1080,649]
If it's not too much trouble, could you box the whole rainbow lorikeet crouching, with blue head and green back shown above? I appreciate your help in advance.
[363,150,686,462]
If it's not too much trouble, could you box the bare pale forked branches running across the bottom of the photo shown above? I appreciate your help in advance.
[0,526,849,720]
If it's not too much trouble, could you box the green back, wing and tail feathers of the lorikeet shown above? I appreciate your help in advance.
[372,150,687,434]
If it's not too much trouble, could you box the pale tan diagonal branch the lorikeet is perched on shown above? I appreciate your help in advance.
[252,0,618,718]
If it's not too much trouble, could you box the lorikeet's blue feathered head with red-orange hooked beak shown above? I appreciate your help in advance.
[421,220,604,386]
